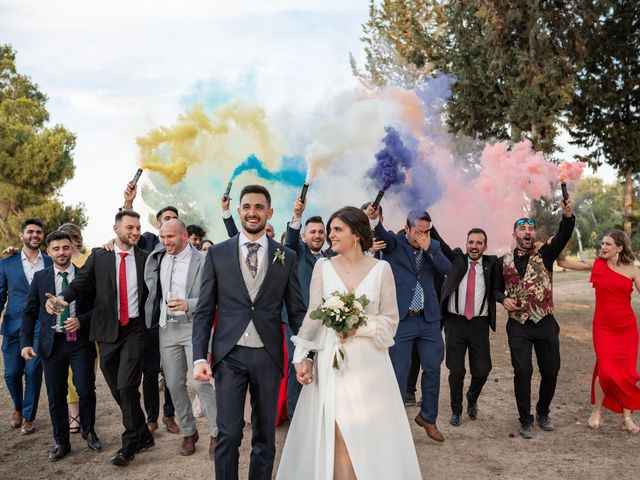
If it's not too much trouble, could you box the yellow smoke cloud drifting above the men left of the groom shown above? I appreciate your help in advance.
[136,102,284,185]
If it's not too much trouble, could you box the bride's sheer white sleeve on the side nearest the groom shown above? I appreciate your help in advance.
[291,259,327,363]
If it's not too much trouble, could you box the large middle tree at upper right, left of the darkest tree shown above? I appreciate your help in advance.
[447,0,578,154]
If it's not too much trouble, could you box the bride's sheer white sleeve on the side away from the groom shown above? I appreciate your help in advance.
[355,261,400,349]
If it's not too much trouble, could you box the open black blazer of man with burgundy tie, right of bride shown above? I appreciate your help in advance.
[431,228,498,332]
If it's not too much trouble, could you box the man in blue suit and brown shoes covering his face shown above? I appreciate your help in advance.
[367,205,451,442]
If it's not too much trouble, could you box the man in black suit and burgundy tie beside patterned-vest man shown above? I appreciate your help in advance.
[431,228,498,427]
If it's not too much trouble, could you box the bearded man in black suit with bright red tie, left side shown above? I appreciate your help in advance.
[47,210,155,466]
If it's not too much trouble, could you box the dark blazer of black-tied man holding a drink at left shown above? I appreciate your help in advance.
[20,267,93,358]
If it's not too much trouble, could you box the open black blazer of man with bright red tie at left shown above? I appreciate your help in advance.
[62,247,149,343]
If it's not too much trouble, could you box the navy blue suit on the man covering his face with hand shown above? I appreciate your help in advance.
[375,222,451,424]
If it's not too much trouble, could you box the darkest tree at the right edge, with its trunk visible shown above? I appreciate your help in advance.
[569,0,640,235]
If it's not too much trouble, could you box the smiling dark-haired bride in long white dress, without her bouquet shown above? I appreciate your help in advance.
[276,207,421,480]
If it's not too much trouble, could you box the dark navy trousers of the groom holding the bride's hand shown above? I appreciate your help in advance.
[213,346,282,480]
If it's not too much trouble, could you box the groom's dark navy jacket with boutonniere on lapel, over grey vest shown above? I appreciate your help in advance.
[192,235,306,372]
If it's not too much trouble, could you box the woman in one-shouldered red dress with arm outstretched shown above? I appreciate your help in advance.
[558,230,640,433]
